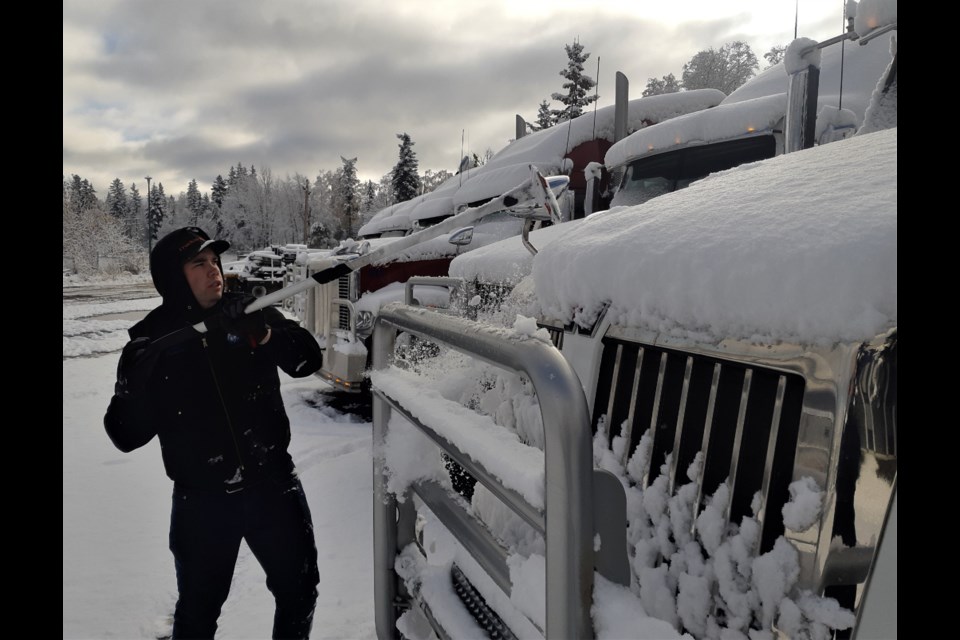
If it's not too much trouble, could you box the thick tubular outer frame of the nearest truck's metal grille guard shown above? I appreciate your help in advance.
[374,303,594,638]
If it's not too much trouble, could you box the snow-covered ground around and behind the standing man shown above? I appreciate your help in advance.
[63,279,375,639]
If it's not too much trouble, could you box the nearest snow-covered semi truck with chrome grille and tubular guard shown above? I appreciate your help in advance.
[371,2,898,640]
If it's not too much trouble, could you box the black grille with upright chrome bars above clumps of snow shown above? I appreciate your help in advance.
[593,337,805,553]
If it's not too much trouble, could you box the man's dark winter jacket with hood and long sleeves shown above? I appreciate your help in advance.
[104,229,322,490]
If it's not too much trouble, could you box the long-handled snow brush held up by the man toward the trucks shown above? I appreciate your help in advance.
[150,164,569,350]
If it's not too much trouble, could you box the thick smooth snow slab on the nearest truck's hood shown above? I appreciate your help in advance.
[533,128,897,343]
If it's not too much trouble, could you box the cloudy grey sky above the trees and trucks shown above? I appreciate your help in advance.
[63,0,842,197]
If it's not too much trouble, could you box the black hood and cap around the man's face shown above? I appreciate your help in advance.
[150,227,230,321]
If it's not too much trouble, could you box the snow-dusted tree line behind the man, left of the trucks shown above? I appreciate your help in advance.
[63,133,456,273]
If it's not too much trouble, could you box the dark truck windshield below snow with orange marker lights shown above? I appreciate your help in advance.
[611,135,777,206]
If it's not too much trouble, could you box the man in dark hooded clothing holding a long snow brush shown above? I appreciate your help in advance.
[104,227,321,638]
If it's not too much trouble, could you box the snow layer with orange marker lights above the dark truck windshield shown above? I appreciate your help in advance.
[604,93,787,168]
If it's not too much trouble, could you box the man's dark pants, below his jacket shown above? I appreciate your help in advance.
[170,478,320,638]
